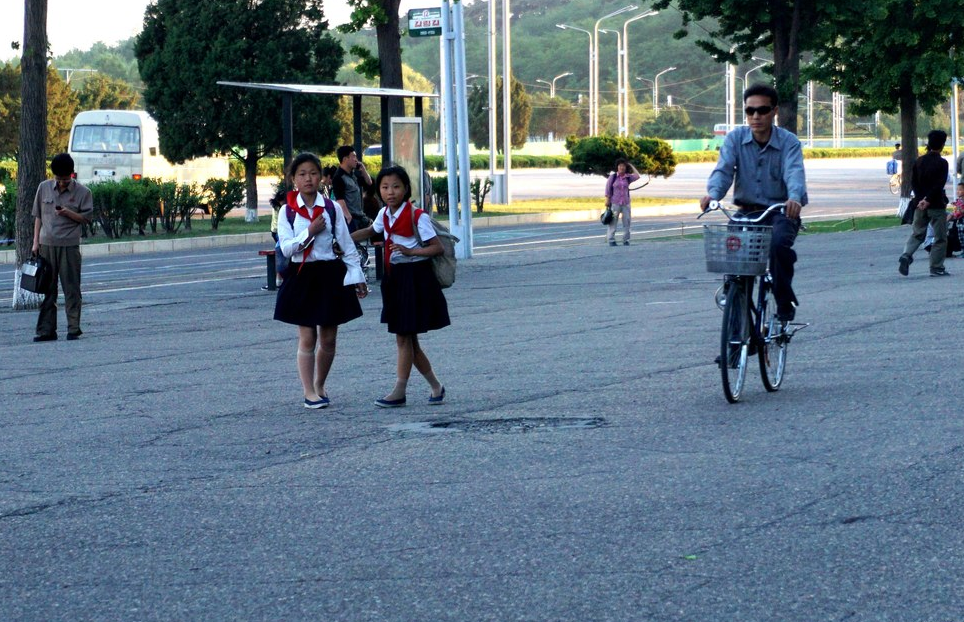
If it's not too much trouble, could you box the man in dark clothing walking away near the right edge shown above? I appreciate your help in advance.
[897,130,948,276]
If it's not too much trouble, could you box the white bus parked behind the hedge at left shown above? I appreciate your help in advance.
[67,110,228,184]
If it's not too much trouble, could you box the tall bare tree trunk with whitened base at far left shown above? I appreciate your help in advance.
[13,0,47,309]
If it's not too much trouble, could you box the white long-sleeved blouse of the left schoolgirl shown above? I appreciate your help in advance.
[278,193,365,285]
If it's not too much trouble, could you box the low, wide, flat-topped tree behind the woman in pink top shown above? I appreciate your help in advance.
[566,135,676,177]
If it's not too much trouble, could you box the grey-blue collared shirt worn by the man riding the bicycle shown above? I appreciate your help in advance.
[706,125,807,210]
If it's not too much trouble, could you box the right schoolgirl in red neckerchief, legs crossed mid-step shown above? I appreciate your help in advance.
[352,166,451,408]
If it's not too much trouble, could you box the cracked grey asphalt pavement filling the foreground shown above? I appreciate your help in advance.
[0,222,964,622]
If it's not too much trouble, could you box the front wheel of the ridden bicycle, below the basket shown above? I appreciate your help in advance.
[720,277,753,404]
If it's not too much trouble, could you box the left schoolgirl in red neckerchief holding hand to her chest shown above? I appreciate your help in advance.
[274,153,368,409]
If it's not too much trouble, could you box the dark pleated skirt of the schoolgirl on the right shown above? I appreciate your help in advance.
[382,261,451,335]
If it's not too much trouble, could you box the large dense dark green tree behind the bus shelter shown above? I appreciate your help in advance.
[135,0,343,209]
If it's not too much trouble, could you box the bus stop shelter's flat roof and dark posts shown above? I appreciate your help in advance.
[218,81,438,169]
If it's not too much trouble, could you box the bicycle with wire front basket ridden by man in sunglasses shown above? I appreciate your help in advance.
[697,201,809,404]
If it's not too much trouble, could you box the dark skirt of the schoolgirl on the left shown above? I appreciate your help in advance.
[274,259,362,326]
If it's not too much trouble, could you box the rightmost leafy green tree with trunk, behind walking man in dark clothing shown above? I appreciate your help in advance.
[810,0,964,191]
